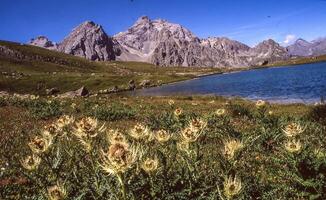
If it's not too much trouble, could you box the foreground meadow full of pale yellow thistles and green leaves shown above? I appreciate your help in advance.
[0,95,326,200]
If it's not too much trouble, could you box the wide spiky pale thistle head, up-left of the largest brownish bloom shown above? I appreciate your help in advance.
[74,117,106,138]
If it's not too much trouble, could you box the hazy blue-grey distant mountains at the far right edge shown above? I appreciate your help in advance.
[287,38,326,57]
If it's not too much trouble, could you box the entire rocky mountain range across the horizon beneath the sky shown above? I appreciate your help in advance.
[29,16,326,67]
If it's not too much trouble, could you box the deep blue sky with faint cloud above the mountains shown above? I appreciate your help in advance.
[0,0,326,46]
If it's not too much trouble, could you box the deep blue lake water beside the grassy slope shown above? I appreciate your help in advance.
[133,62,326,103]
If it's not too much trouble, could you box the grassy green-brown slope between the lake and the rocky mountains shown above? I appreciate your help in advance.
[0,41,221,94]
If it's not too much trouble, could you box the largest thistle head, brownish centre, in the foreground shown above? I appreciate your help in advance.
[100,142,138,174]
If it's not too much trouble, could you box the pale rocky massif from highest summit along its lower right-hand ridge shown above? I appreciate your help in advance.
[114,16,287,67]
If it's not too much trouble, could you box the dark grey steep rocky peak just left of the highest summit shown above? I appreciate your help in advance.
[58,21,115,61]
